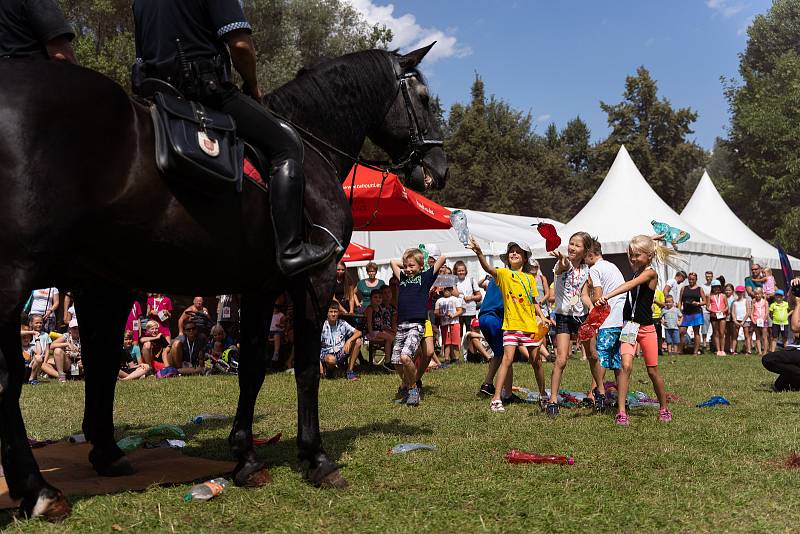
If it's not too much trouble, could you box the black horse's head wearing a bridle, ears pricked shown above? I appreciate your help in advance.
[369,43,448,191]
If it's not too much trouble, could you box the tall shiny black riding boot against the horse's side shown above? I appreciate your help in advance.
[269,160,337,276]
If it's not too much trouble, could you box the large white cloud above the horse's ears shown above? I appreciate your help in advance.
[350,0,472,63]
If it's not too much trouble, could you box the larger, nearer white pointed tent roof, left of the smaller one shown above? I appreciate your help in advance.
[532,146,750,258]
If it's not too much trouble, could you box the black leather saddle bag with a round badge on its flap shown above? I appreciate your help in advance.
[151,93,244,192]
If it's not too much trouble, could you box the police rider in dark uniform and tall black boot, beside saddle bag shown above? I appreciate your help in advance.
[133,0,337,276]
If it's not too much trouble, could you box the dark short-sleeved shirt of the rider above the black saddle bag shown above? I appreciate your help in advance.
[133,0,252,71]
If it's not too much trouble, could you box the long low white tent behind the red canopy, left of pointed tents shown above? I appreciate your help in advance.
[348,208,563,280]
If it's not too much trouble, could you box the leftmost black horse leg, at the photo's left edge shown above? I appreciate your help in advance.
[0,280,70,521]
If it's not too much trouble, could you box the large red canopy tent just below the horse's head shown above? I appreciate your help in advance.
[342,166,450,232]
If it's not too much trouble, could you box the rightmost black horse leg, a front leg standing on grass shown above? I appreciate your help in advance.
[291,282,347,488]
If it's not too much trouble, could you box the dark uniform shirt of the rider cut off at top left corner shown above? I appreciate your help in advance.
[0,0,75,59]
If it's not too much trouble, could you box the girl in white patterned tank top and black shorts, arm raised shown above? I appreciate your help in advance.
[546,232,592,417]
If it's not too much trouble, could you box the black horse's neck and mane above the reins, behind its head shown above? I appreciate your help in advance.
[265,50,396,152]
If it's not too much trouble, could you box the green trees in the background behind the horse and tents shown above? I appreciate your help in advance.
[60,0,800,254]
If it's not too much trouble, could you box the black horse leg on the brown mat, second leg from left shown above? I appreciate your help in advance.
[75,286,134,476]
